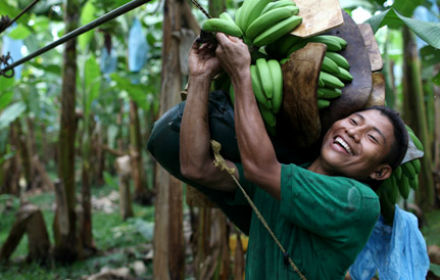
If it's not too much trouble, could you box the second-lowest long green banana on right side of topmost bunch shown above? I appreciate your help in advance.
[245,7,293,41]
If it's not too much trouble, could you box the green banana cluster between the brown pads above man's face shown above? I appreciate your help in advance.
[266,34,353,109]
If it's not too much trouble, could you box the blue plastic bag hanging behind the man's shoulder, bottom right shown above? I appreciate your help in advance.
[350,205,429,280]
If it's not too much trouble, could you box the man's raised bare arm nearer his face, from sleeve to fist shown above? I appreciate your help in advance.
[216,33,281,200]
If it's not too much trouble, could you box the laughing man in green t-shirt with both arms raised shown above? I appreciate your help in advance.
[149,33,407,279]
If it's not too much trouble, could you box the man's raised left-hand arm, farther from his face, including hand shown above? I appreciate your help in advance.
[180,43,239,191]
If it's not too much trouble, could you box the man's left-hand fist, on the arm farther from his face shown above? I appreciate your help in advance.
[188,38,221,80]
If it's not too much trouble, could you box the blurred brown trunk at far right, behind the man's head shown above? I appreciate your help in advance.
[403,27,434,211]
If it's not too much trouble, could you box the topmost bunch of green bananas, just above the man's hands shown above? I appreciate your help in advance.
[202,0,302,47]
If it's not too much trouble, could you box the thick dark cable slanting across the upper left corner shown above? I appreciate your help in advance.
[0,0,151,75]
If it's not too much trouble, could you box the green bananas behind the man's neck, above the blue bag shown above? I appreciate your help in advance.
[377,126,424,224]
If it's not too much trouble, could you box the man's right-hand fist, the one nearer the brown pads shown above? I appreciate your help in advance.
[216,32,251,81]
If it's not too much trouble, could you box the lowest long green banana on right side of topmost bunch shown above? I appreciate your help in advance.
[253,16,302,47]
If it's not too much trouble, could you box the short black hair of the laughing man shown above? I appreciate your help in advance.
[364,106,408,170]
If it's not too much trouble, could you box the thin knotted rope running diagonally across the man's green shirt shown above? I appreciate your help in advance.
[210,140,307,280]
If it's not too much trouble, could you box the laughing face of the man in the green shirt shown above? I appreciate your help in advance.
[321,110,395,179]
